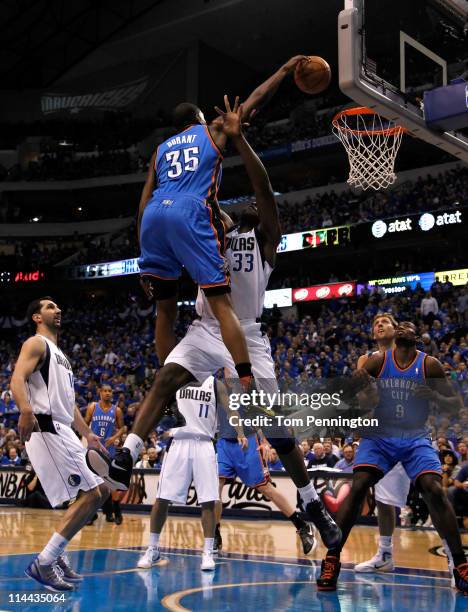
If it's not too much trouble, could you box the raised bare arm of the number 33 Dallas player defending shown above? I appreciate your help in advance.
[216,96,281,266]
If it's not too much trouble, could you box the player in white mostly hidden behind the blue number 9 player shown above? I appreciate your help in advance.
[354,313,453,576]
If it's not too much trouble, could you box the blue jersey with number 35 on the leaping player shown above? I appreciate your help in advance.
[153,124,223,202]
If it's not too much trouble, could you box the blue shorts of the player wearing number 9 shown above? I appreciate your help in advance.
[354,438,442,481]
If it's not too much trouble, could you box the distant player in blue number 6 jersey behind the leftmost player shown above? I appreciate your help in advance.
[85,384,127,525]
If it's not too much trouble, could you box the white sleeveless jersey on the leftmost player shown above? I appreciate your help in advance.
[26,334,75,425]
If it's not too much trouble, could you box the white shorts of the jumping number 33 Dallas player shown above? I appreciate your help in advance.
[164,320,278,393]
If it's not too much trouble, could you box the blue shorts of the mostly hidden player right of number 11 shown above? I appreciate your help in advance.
[216,434,270,487]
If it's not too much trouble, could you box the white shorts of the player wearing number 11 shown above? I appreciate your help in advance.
[156,438,219,504]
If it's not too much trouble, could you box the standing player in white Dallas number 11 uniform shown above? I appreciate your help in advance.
[137,376,223,571]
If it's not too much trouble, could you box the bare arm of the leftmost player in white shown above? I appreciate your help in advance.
[10,336,46,442]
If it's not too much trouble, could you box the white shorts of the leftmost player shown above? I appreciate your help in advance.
[26,421,104,508]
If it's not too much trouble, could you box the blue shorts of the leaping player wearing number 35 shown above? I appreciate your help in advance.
[138,194,229,289]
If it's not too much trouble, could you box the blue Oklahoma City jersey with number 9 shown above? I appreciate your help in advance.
[374,349,429,438]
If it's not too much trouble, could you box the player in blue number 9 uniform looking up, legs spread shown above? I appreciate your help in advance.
[317,321,468,595]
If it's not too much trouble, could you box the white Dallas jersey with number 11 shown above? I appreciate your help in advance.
[173,376,218,440]
